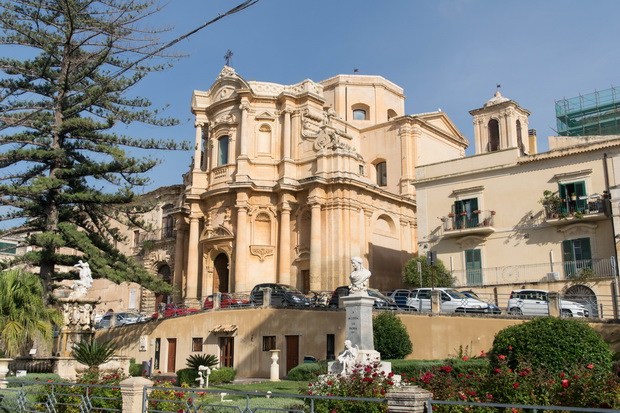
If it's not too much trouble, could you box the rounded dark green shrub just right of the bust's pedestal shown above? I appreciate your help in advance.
[372,312,413,359]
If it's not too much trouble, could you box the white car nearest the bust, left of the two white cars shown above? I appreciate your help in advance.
[407,288,492,314]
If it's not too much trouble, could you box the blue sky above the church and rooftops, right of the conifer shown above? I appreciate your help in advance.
[121,0,620,189]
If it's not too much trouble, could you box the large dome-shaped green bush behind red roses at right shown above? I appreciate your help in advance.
[489,317,612,374]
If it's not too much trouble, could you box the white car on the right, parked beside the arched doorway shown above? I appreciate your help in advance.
[506,289,590,317]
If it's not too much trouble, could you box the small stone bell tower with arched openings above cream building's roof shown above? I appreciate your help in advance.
[469,91,536,155]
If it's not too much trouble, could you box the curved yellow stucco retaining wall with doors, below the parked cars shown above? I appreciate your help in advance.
[97,308,620,377]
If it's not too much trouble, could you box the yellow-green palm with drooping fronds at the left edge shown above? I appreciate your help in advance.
[0,270,62,357]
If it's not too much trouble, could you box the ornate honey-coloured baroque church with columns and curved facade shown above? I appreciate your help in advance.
[173,66,468,305]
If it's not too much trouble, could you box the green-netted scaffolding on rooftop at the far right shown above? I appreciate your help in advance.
[555,87,620,136]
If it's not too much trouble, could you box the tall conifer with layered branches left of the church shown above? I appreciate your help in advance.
[0,0,191,292]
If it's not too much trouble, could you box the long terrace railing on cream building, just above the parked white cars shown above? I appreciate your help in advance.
[452,258,614,286]
